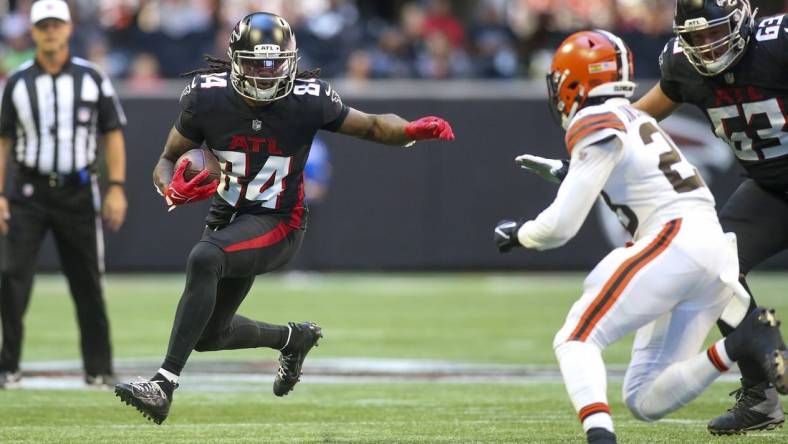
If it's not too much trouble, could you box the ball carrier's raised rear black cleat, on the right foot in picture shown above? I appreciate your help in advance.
[274,322,323,396]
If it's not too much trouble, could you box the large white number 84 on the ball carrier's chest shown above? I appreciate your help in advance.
[218,151,291,209]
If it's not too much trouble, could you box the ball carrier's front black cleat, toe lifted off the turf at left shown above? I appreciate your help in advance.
[115,379,178,424]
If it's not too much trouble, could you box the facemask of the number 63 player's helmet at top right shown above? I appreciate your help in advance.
[673,2,753,76]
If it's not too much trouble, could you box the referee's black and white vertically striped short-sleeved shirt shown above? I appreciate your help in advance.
[0,57,126,174]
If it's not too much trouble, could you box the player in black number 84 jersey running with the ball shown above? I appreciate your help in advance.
[115,13,454,424]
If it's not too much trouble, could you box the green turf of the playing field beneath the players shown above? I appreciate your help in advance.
[0,274,788,443]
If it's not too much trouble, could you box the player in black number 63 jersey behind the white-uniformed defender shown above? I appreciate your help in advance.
[635,0,788,434]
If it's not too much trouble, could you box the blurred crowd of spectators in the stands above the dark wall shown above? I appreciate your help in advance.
[0,0,788,90]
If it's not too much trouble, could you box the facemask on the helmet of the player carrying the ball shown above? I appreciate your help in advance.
[228,45,298,102]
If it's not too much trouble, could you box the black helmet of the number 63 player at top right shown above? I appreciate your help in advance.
[673,0,758,76]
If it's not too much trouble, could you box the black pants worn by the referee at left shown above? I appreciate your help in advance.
[0,174,112,375]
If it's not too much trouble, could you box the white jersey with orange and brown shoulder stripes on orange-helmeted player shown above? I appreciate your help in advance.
[566,99,714,239]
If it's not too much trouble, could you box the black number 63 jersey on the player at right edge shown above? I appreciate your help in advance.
[660,14,788,192]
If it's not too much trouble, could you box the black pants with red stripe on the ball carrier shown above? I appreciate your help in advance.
[162,214,304,374]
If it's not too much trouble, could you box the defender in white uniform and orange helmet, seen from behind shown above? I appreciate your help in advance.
[495,31,788,443]
